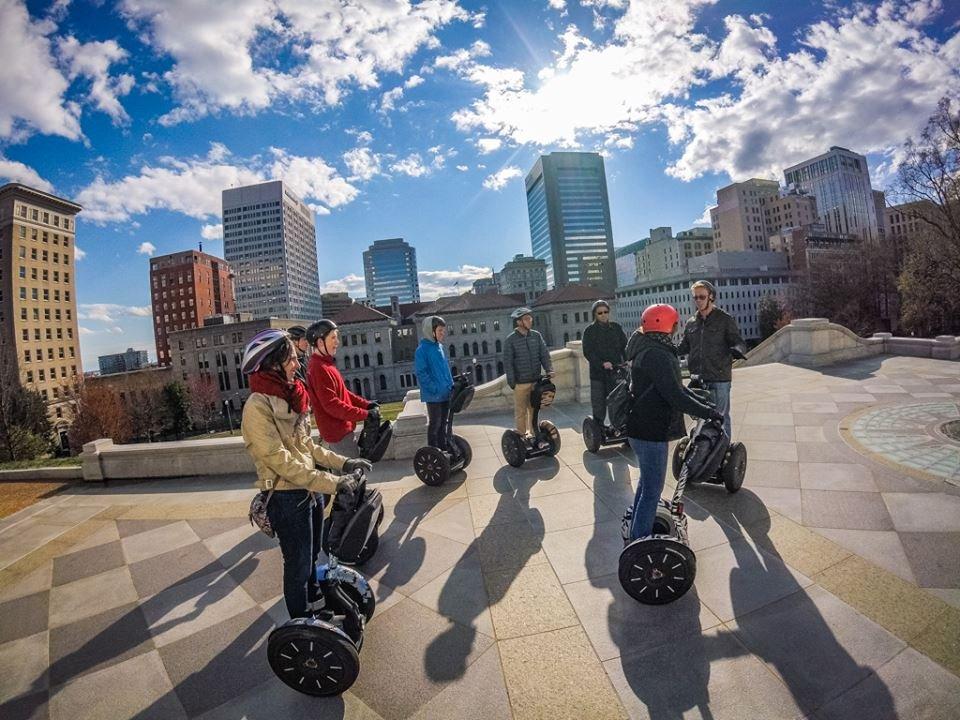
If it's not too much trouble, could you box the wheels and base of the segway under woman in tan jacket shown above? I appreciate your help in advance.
[267,472,376,696]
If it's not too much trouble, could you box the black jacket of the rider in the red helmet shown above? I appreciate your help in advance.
[627,331,715,442]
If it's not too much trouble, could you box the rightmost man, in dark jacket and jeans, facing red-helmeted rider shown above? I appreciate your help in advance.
[678,280,746,437]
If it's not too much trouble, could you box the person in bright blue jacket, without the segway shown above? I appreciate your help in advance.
[413,315,453,450]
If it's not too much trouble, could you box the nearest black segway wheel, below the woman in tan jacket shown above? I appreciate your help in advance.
[267,618,360,696]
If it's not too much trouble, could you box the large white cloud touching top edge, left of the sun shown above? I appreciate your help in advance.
[120,0,478,124]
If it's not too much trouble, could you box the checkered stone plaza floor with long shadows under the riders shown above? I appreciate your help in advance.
[0,357,960,720]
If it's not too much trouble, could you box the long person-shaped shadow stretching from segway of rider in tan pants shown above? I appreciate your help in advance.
[424,458,559,682]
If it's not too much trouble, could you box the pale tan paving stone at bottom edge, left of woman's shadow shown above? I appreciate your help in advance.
[50,650,187,720]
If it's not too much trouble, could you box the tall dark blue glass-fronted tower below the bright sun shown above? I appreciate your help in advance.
[526,152,617,291]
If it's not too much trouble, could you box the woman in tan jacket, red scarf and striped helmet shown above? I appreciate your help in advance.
[241,329,372,618]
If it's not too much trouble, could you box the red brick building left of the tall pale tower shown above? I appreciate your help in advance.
[150,250,236,365]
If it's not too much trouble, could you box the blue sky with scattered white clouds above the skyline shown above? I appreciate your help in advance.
[0,0,960,369]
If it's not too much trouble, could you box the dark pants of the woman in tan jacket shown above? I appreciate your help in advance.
[267,490,323,618]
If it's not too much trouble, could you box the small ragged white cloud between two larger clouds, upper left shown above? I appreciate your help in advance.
[57,35,134,124]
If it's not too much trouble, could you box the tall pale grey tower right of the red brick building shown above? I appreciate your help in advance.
[223,180,321,319]
